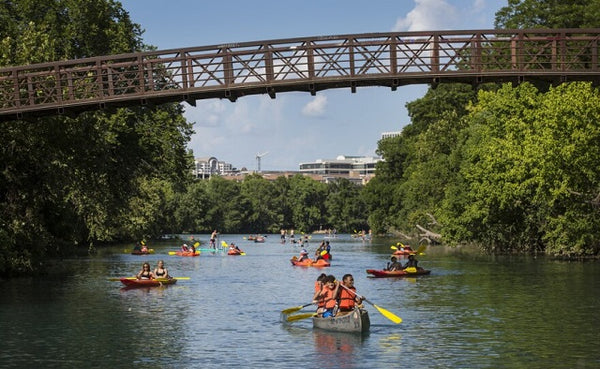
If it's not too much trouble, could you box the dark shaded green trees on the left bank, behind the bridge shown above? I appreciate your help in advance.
[0,0,192,275]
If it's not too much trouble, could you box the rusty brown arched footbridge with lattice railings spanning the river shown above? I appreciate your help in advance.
[0,28,600,121]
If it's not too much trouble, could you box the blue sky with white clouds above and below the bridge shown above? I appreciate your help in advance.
[121,0,507,170]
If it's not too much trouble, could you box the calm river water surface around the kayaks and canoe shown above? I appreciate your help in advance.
[0,235,600,368]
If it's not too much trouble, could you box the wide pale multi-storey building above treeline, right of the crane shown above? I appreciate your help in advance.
[300,155,381,179]
